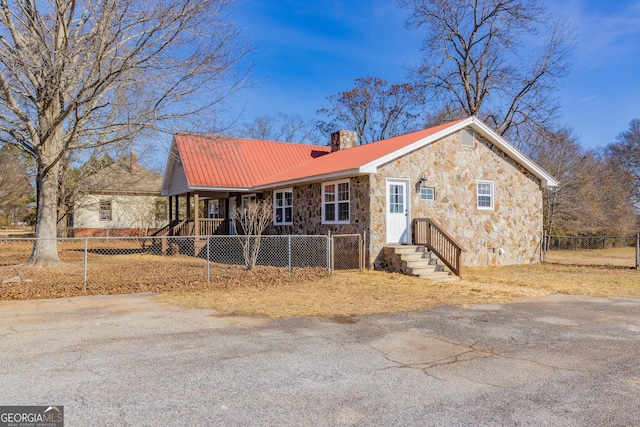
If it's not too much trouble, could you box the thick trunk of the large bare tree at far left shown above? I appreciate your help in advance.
[28,163,60,267]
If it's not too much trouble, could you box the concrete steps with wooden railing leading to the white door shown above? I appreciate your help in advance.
[385,245,458,280]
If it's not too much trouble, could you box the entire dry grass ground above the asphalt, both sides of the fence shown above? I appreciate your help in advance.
[0,241,640,317]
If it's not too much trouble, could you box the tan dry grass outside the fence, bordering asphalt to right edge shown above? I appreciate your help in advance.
[159,264,640,317]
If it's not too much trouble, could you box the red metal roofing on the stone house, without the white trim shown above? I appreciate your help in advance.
[175,120,468,189]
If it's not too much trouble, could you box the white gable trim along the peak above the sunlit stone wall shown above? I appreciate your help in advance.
[359,117,558,187]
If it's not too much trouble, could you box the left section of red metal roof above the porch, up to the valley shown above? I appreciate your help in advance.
[175,134,331,188]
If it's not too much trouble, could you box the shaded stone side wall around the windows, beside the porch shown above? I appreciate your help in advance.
[263,176,369,242]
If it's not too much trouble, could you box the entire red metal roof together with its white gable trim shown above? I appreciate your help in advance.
[171,117,557,190]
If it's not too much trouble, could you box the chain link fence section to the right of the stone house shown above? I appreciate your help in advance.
[542,234,640,269]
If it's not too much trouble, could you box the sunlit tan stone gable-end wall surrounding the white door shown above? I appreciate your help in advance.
[369,128,542,266]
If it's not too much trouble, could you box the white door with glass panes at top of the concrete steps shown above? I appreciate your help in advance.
[387,179,411,243]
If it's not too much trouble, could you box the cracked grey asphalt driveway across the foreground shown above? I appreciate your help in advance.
[0,294,640,427]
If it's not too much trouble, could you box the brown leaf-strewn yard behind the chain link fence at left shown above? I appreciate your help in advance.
[0,239,327,299]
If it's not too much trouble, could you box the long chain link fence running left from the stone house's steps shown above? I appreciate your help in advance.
[0,235,362,290]
